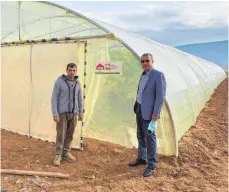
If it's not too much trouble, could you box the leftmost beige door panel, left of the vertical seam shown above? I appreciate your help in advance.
[1,45,31,135]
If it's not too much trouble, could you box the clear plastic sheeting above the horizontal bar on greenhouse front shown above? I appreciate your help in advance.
[1,1,107,42]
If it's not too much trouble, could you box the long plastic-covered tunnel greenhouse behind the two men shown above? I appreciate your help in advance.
[1,1,226,155]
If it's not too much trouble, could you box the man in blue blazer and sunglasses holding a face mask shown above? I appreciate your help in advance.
[129,53,166,177]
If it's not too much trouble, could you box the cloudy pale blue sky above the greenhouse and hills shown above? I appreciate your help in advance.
[55,1,229,46]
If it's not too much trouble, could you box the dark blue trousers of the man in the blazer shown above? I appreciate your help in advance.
[136,104,157,168]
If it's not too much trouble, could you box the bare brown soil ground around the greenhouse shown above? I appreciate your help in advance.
[1,79,228,192]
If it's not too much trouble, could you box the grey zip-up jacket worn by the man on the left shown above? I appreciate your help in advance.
[51,75,83,116]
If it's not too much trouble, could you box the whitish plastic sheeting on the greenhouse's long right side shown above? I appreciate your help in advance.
[96,20,226,147]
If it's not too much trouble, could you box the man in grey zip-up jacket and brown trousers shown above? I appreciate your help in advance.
[51,63,83,166]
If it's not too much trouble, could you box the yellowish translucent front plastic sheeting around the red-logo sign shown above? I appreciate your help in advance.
[76,39,176,155]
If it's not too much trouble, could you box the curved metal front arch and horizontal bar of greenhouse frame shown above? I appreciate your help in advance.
[0,1,178,156]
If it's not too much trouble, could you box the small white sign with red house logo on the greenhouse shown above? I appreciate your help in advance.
[95,61,122,74]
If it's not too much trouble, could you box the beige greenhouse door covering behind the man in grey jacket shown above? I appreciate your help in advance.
[2,41,86,149]
